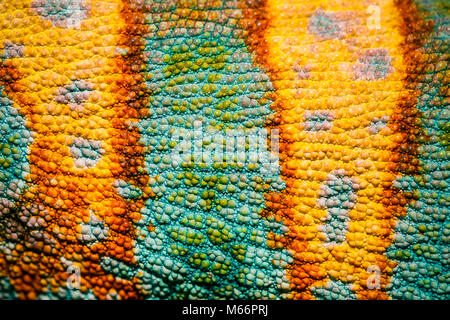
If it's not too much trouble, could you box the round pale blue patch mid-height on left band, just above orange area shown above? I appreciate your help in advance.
[69,137,105,169]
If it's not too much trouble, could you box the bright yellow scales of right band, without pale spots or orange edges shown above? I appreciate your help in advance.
[264,0,408,299]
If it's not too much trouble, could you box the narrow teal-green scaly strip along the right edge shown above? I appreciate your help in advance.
[388,0,450,300]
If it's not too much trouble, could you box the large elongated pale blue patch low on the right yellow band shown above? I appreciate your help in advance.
[317,170,358,245]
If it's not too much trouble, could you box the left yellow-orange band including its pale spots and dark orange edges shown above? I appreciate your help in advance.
[1,1,151,299]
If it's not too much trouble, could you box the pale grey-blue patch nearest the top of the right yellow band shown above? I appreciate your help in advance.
[308,9,345,40]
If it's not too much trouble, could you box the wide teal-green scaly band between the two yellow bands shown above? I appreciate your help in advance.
[104,1,290,299]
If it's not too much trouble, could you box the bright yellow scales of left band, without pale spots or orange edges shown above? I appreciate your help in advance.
[0,0,139,298]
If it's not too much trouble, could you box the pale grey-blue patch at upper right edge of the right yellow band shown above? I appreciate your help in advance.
[354,49,394,80]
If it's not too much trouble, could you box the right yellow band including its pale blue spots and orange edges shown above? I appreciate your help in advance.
[244,0,448,299]
